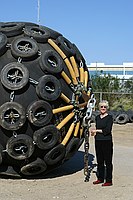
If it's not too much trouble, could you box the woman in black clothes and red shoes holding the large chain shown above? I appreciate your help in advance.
[90,100,113,186]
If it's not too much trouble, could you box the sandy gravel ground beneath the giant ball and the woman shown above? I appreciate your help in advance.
[0,123,133,200]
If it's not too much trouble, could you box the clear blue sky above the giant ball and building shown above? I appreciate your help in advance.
[0,0,133,64]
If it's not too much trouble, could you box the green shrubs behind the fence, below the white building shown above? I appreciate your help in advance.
[91,71,133,110]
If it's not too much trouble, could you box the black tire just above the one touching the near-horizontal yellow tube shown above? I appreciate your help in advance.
[36,75,61,101]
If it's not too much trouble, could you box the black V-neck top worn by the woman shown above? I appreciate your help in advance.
[95,114,113,140]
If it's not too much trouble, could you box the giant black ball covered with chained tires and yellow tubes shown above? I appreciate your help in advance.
[0,22,90,177]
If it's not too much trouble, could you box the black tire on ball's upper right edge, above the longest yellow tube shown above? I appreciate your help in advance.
[56,36,75,57]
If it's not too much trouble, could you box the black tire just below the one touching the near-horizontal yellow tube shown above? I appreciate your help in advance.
[33,125,60,150]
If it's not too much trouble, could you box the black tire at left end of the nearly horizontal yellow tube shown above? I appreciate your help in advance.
[27,100,53,127]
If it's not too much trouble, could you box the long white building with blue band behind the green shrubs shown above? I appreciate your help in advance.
[87,62,133,79]
